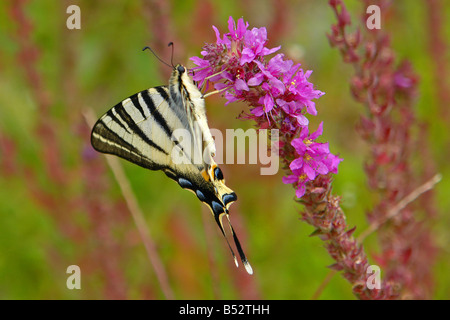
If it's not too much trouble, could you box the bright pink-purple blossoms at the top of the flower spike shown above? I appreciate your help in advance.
[191,17,342,198]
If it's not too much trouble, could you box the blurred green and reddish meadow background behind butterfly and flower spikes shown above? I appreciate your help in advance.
[0,0,450,299]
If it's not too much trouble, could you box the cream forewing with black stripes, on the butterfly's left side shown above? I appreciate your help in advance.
[91,86,195,170]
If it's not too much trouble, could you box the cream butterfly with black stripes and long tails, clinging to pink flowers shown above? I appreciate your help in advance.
[91,58,253,274]
